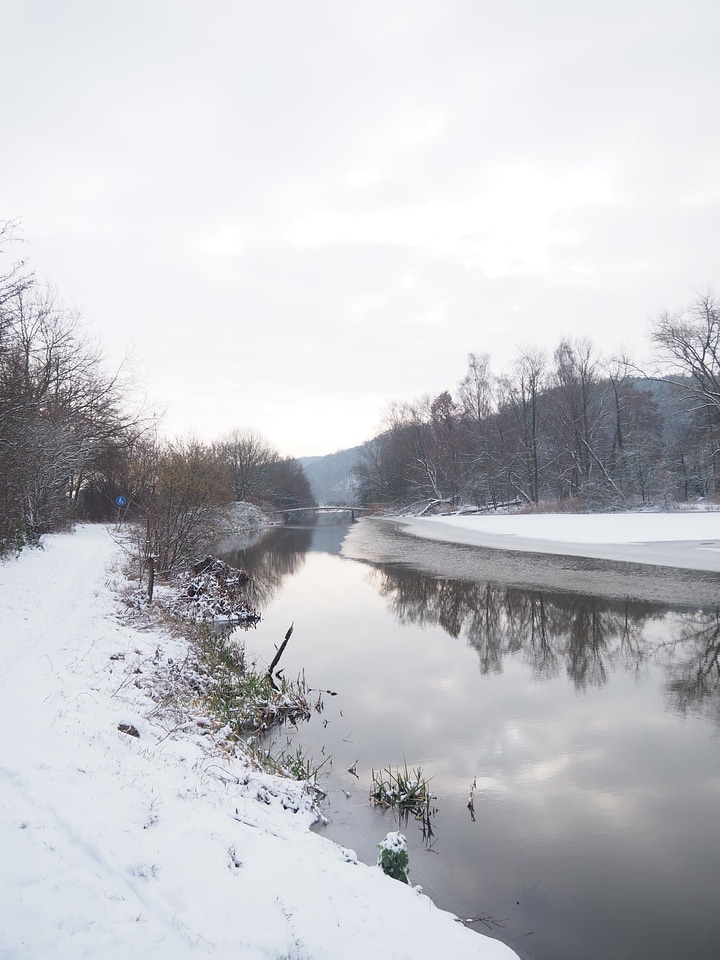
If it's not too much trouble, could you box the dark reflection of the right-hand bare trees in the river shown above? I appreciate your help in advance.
[371,566,704,710]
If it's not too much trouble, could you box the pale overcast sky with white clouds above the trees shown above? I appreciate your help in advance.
[0,0,720,456]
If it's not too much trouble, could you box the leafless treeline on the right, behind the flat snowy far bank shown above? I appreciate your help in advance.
[356,295,720,509]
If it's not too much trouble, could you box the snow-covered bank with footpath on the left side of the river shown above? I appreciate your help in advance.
[0,526,515,960]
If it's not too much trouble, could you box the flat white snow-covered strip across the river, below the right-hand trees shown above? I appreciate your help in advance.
[396,512,720,572]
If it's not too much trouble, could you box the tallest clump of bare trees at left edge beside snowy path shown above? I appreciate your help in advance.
[0,286,143,541]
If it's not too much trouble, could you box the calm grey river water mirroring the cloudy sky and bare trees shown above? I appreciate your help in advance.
[219,520,720,960]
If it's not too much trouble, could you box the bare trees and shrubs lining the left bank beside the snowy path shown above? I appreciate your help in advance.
[0,221,313,570]
